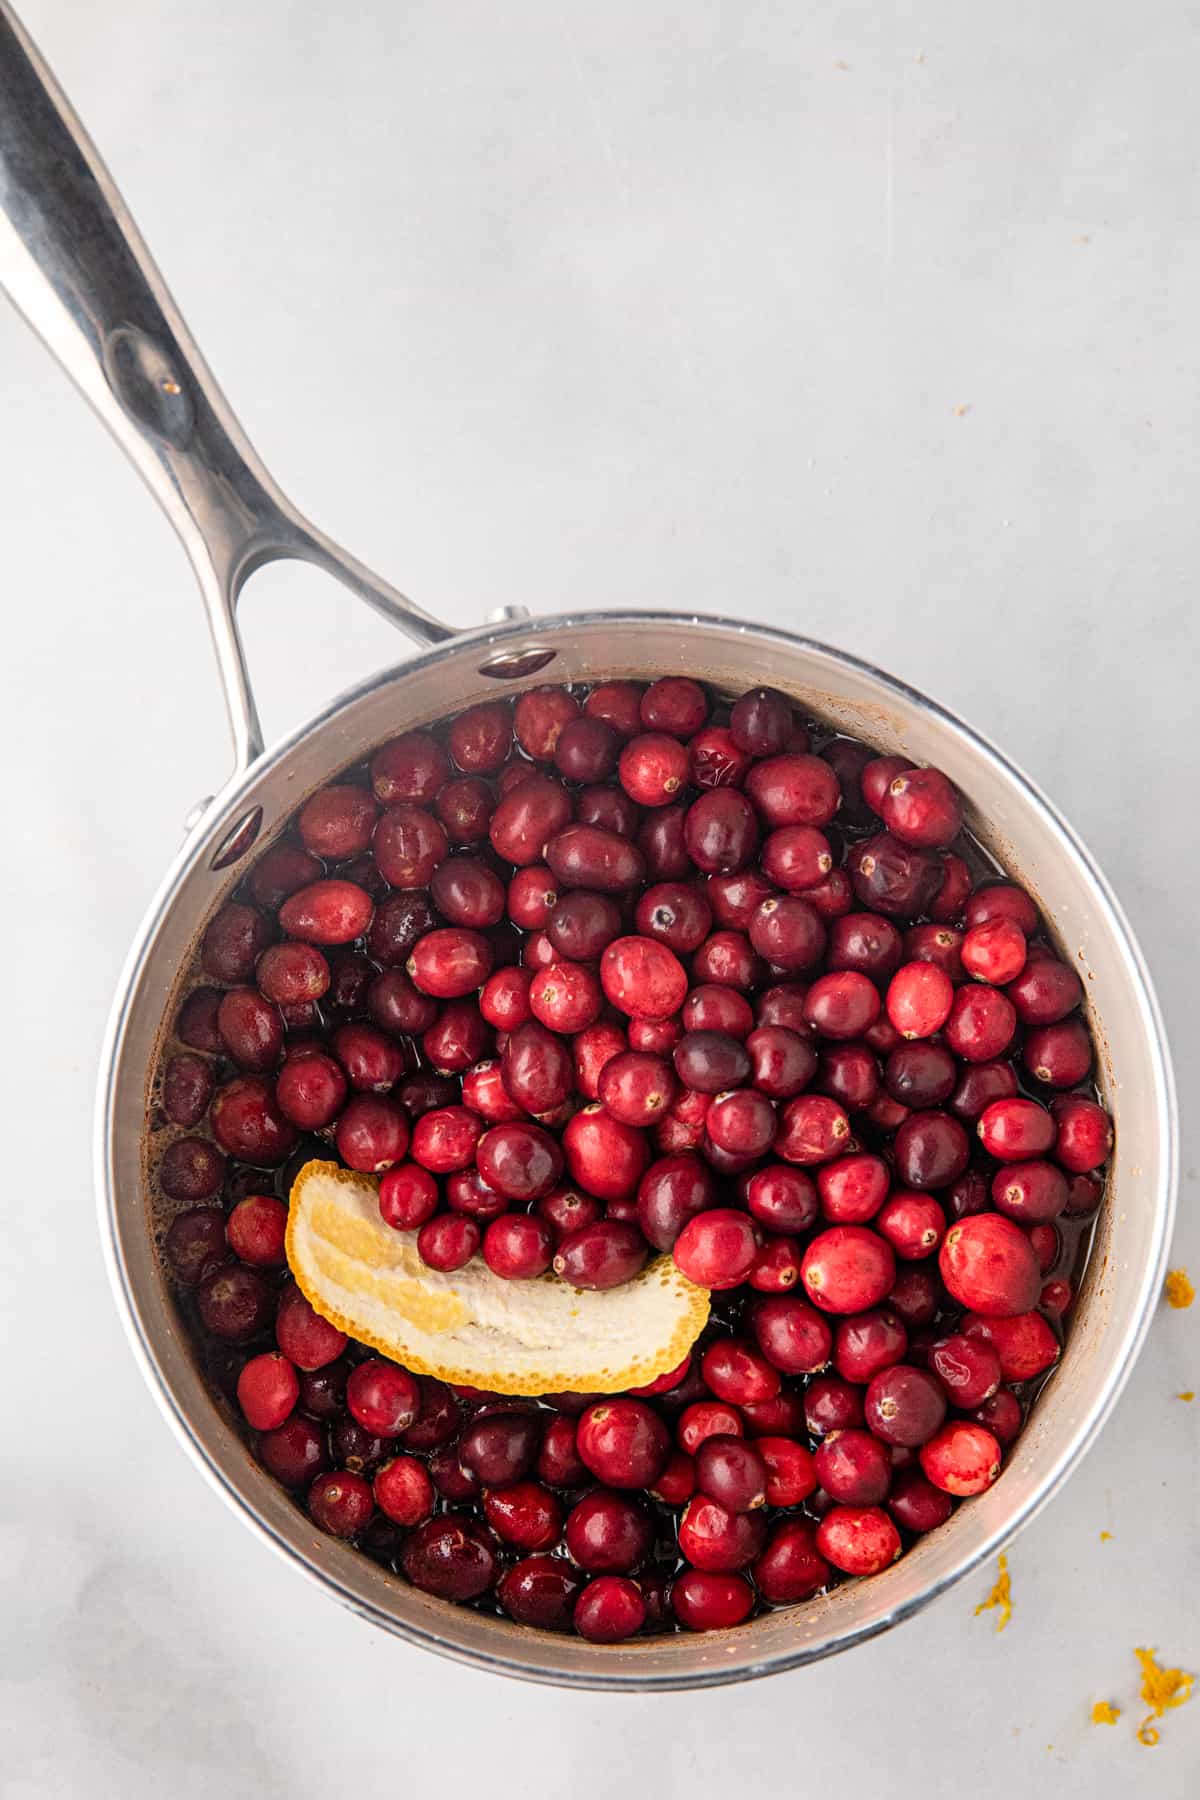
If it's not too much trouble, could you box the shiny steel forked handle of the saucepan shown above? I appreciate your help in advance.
[0,0,453,769]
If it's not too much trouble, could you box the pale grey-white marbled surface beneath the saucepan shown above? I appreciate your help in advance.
[0,0,1200,1800]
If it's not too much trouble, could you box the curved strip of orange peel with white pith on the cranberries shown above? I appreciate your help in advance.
[286,1161,709,1395]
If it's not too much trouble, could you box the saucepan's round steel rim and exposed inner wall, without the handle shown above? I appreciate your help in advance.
[97,614,1173,1687]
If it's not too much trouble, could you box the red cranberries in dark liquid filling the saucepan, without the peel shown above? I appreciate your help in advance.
[151,677,1112,1642]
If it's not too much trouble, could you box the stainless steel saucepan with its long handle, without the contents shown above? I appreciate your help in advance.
[0,4,1177,1688]
